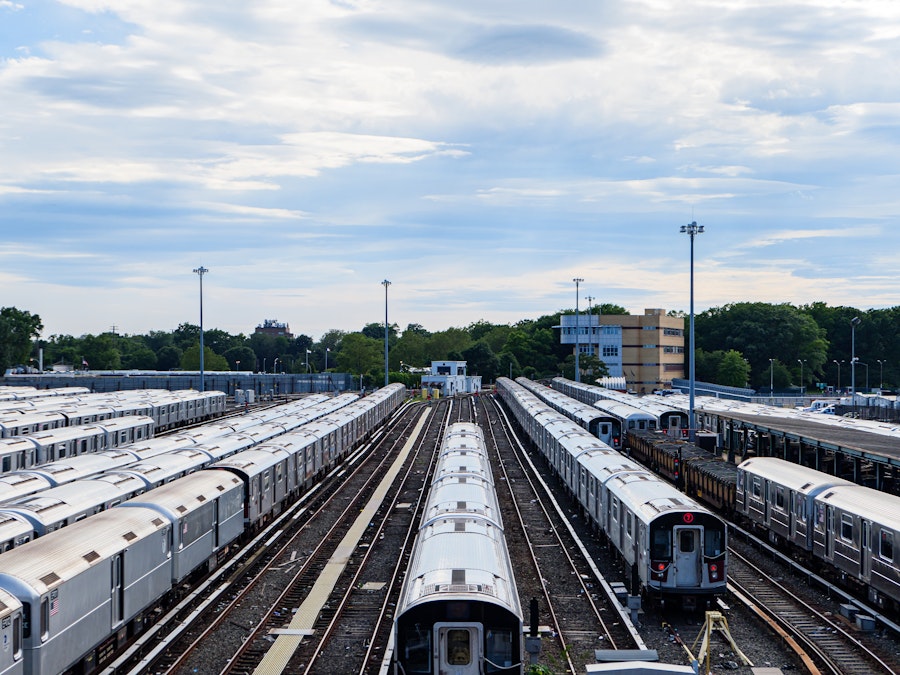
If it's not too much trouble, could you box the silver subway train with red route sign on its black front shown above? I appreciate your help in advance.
[497,378,728,609]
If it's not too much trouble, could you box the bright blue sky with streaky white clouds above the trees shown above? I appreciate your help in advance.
[0,0,900,339]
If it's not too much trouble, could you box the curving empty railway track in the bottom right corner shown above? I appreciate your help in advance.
[728,541,897,675]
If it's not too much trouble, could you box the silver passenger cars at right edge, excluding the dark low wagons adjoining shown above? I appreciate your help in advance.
[735,457,900,615]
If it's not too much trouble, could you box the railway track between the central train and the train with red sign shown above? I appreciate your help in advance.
[479,397,642,673]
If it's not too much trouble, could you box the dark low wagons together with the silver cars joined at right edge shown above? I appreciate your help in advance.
[627,432,900,617]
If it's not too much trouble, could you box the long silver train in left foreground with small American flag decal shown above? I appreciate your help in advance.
[0,384,406,675]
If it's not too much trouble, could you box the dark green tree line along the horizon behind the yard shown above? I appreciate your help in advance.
[0,302,900,390]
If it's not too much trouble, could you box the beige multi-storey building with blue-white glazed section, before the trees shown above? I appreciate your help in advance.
[559,309,685,393]
